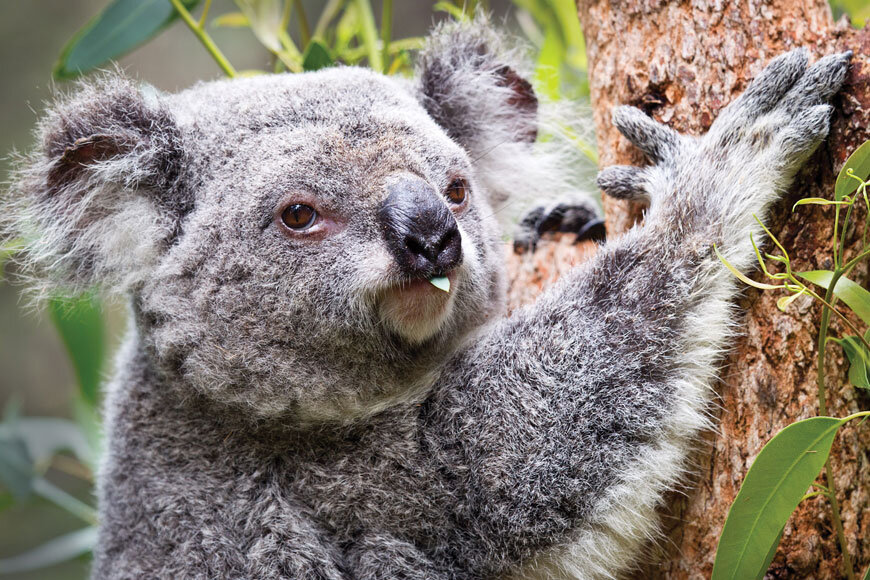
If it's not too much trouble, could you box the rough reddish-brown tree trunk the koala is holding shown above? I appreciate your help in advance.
[510,0,870,578]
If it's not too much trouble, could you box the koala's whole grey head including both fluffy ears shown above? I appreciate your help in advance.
[7,23,537,422]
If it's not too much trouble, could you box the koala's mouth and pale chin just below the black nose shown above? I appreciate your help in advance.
[380,270,459,344]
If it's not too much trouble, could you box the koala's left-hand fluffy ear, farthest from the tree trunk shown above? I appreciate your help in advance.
[0,74,192,291]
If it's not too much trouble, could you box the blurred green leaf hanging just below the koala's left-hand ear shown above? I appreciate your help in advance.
[49,295,105,406]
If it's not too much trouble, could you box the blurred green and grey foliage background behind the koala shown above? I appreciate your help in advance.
[0,0,870,579]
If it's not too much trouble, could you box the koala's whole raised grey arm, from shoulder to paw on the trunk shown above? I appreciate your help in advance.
[421,52,850,578]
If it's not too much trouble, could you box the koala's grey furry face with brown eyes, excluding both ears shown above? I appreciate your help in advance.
[138,69,510,418]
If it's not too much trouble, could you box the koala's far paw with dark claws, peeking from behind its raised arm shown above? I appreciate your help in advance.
[514,200,605,254]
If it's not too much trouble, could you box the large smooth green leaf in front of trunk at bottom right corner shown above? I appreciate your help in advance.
[712,417,845,580]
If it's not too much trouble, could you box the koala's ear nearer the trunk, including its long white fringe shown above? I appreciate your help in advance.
[417,15,599,228]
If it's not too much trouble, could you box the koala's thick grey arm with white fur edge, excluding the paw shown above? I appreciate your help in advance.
[429,228,732,577]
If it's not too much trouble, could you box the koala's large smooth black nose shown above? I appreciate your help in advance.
[378,177,462,278]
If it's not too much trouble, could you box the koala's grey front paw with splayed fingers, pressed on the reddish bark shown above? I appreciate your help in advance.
[598,50,851,238]
